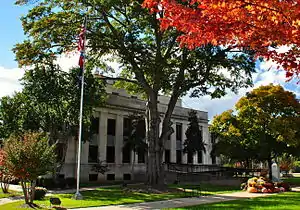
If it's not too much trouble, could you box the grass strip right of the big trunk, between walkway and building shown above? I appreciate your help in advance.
[170,183,240,195]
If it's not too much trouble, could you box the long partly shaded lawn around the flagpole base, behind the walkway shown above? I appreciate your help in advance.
[0,184,238,210]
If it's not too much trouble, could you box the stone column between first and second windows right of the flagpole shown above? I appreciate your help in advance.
[98,111,108,161]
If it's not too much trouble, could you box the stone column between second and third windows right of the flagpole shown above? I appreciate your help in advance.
[115,115,123,165]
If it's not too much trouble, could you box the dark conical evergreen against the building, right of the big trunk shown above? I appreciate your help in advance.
[183,110,206,162]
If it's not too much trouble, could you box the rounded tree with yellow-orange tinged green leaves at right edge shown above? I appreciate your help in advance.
[210,84,300,177]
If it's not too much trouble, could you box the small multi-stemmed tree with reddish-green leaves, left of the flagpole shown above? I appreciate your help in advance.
[3,133,56,204]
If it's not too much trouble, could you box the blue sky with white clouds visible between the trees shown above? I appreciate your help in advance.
[0,0,300,120]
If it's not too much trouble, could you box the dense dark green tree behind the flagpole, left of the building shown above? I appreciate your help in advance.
[0,65,106,163]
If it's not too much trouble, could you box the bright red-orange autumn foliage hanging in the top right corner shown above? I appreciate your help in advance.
[144,0,300,79]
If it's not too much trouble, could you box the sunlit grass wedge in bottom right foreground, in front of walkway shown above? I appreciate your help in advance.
[170,192,300,210]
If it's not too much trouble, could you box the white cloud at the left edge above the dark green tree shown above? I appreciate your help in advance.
[0,66,25,97]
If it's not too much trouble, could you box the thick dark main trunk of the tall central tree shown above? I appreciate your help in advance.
[146,93,164,188]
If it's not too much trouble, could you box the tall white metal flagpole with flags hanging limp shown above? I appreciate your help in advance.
[74,16,87,200]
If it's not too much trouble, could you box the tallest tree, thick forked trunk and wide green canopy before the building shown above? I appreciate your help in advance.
[14,0,255,186]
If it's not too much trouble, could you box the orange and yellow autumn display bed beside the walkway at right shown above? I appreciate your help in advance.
[241,177,291,193]
